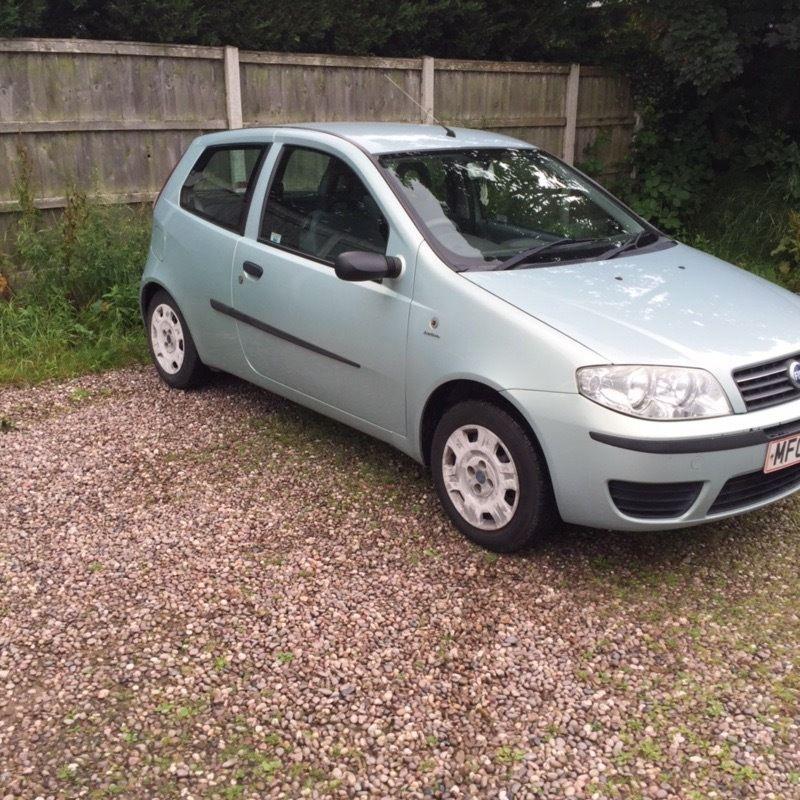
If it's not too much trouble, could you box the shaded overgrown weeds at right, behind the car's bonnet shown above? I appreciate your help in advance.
[579,122,800,292]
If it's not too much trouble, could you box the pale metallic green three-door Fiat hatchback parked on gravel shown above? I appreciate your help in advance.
[141,123,800,550]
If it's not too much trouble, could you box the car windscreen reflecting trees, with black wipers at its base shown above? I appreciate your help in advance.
[380,149,644,269]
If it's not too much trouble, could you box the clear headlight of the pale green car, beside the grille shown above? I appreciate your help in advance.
[578,366,731,419]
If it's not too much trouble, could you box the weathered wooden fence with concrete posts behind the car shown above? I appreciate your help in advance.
[0,39,634,247]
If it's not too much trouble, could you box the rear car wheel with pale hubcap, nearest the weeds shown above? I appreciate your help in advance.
[147,289,208,389]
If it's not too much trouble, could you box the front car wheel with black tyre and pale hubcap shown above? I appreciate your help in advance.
[431,400,557,552]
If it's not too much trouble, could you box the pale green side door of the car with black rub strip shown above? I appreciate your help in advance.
[232,141,414,435]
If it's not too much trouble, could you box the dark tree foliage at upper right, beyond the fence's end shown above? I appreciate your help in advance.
[618,0,800,230]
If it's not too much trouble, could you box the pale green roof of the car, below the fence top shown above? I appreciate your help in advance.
[204,122,533,155]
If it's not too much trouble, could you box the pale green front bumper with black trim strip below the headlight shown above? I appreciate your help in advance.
[504,389,800,530]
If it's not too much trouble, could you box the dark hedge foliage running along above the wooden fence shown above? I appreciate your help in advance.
[0,0,600,60]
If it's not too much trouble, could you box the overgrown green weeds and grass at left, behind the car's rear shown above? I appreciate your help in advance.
[0,150,150,390]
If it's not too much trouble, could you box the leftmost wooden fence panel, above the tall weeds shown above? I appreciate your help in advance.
[0,40,227,211]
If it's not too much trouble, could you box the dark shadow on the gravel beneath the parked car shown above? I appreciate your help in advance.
[209,373,796,587]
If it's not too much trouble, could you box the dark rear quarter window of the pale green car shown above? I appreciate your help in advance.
[181,145,268,233]
